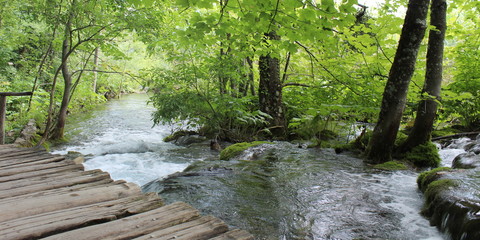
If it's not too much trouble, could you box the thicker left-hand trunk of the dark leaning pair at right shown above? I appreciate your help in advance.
[367,0,430,163]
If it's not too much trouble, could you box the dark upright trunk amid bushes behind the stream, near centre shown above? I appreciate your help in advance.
[258,32,285,137]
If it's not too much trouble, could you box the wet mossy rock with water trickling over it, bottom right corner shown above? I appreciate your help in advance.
[418,167,480,240]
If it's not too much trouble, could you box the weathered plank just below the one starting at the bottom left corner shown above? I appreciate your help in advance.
[45,202,199,240]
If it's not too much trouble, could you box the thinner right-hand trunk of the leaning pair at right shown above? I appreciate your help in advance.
[400,0,447,152]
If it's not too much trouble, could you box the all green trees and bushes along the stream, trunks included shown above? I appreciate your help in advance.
[0,0,480,239]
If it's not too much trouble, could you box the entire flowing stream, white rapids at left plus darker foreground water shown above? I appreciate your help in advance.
[55,95,445,239]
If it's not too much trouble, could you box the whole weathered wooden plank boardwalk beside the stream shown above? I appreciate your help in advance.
[0,145,253,240]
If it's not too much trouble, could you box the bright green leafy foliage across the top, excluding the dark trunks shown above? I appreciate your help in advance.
[0,0,480,144]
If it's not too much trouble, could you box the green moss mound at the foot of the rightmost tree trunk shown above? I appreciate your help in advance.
[405,142,441,167]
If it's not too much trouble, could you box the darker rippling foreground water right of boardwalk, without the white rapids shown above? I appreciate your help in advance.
[143,143,442,239]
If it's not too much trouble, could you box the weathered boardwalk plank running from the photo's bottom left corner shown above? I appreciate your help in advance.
[0,194,163,240]
